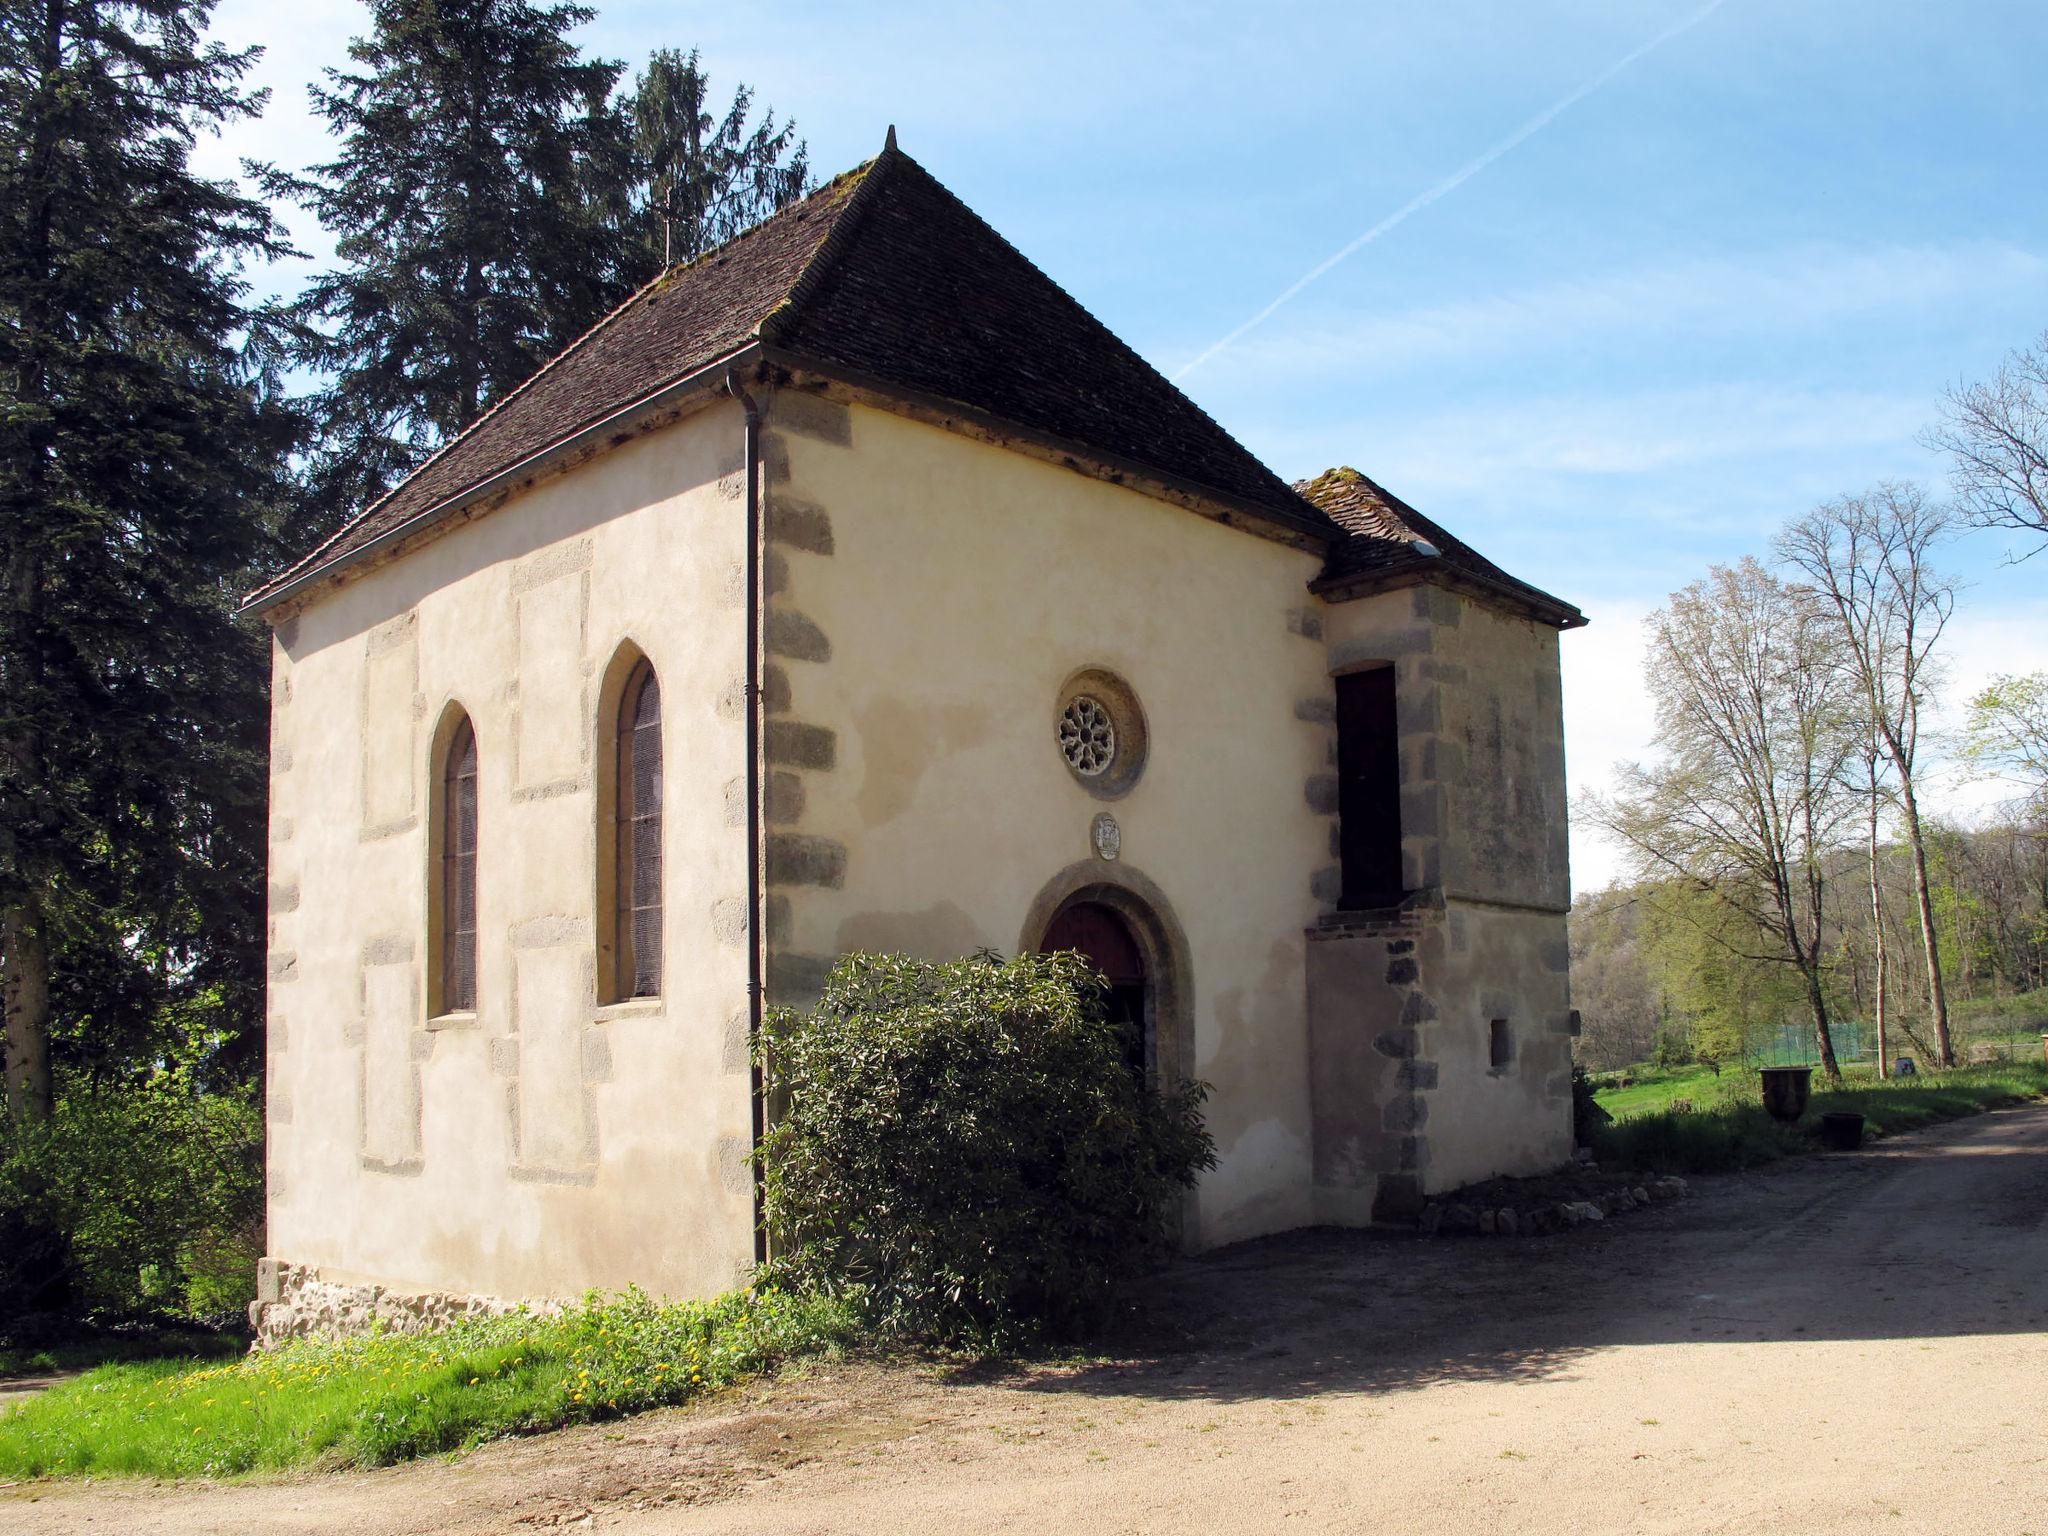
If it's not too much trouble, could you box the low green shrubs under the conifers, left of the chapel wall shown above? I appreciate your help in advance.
[0,1073,262,1333]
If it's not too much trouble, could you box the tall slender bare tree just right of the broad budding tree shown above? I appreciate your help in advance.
[1778,481,1956,1067]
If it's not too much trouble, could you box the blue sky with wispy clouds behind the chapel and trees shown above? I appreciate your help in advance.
[195,0,2048,889]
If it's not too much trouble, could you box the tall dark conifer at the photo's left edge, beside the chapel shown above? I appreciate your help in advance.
[0,0,293,1120]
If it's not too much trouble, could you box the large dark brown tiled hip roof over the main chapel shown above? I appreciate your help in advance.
[252,143,1331,602]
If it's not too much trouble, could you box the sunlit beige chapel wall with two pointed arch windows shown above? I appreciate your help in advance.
[268,403,752,1296]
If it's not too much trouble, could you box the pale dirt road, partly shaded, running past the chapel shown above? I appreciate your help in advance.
[0,1106,2048,1536]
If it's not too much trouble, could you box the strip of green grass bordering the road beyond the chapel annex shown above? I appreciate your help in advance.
[1593,1063,2048,1174]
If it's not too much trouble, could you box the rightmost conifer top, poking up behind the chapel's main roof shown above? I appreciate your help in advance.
[629,47,811,281]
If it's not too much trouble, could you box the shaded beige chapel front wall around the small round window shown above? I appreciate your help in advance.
[768,391,1329,1243]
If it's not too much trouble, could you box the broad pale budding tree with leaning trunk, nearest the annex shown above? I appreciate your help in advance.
[1585,559,1860,1077]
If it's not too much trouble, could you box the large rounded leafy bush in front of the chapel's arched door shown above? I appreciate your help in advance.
[762,954,1217,1346]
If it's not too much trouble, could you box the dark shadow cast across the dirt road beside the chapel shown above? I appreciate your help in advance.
[963,1106,2048,1403]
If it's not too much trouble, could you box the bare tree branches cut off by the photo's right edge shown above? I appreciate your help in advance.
[1925,332,2048,559]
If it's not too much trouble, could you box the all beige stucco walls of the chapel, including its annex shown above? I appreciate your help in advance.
[268,370,1569,1321]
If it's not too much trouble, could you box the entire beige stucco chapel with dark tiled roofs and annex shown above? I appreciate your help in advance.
[250,137,1585,1337]
